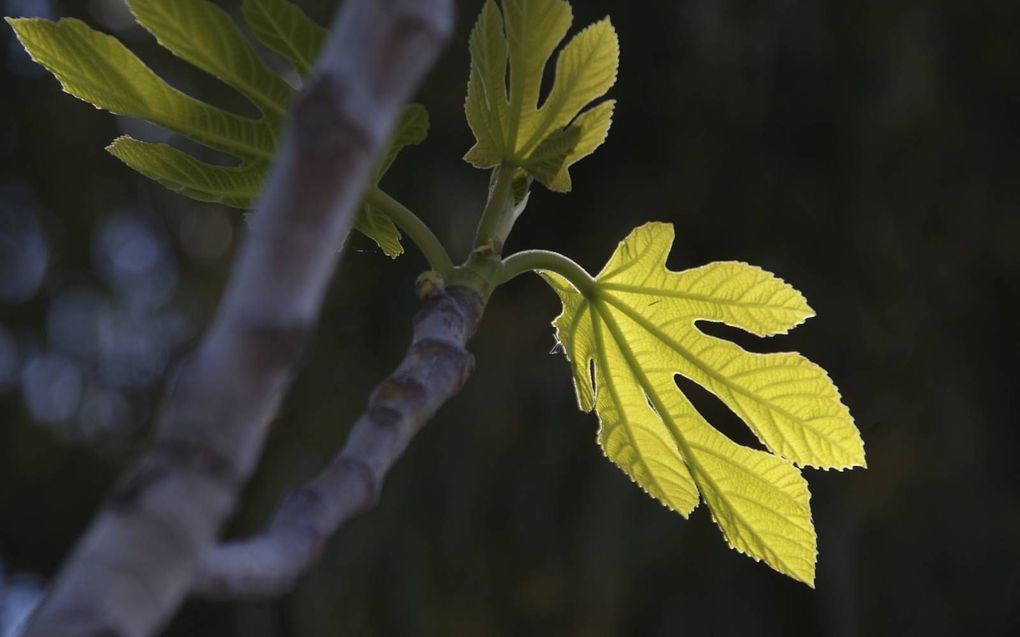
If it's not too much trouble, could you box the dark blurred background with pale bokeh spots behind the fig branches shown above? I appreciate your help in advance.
[0,0,1020,637]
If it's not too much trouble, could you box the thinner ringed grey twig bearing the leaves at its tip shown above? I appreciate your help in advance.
[195,286,482,598]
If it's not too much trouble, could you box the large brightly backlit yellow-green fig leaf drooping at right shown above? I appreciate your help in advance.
[543,223,865,584]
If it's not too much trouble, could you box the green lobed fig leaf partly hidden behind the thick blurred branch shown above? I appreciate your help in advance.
[7,0,428,257]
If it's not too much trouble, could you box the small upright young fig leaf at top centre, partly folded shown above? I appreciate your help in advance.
[464,0,619,192]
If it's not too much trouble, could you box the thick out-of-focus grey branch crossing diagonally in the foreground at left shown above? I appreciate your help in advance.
[27,0,454,637]
